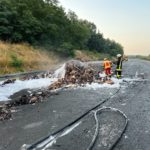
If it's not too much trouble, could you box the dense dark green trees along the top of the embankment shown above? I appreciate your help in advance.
[0,0,123,56]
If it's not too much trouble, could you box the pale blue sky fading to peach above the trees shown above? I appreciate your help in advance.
[59,0,150,55]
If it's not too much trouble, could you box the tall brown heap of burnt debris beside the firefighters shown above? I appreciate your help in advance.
[49,60,113,90]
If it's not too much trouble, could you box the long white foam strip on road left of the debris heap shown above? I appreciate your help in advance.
[0,78,57,101]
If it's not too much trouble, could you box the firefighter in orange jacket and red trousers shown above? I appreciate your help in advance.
[103,58,112,77]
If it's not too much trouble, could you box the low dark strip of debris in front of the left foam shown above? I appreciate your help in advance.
[0,89,58,121]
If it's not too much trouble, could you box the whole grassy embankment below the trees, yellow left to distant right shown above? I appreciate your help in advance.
[0,41,116,75]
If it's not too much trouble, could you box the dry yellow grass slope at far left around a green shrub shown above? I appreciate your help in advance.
[0,41,59,74]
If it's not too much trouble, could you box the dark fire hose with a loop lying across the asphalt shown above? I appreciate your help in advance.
[26,80,128,150]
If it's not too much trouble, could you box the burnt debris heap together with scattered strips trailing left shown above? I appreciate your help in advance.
[0,60,113,120]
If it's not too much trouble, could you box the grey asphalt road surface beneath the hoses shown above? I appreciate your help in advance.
[0,59,150,150]
